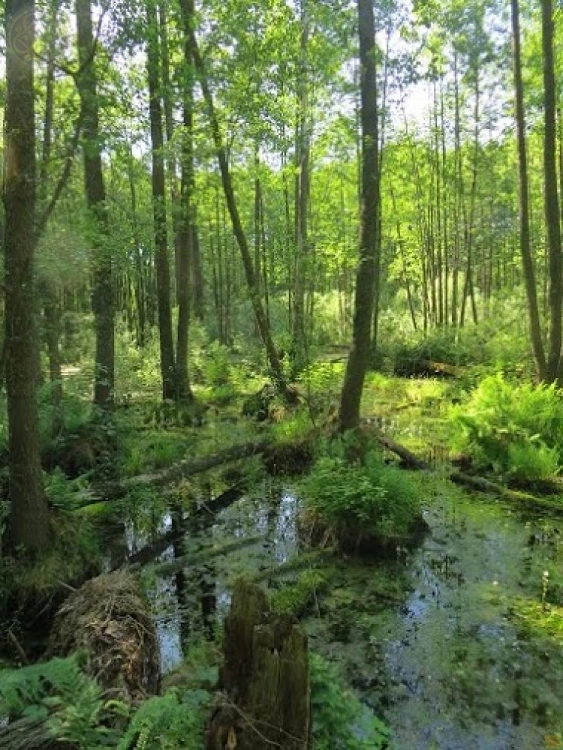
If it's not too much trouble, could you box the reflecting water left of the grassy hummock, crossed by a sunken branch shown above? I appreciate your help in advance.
[145,489,298,671]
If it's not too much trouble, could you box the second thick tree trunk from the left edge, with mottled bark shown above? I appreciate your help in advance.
[76,0,115,409]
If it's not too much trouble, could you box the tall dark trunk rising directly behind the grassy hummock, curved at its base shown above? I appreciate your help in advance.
[339,0,379,431]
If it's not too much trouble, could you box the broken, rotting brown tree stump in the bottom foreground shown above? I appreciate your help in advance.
[207,580,310,750]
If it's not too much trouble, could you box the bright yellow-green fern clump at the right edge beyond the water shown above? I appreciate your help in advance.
[450,374,563,479]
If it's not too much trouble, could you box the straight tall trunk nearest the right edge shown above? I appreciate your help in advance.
[541,0,563,383]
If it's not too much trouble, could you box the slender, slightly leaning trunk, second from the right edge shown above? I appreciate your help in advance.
[511,0,545,380]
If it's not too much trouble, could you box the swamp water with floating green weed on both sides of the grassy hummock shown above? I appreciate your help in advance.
[129,488,563,750]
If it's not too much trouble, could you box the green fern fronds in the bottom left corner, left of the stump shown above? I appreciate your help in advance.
[0,655,211,750]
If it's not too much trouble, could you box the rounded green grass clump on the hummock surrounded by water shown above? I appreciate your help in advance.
[301,450,421,552]
